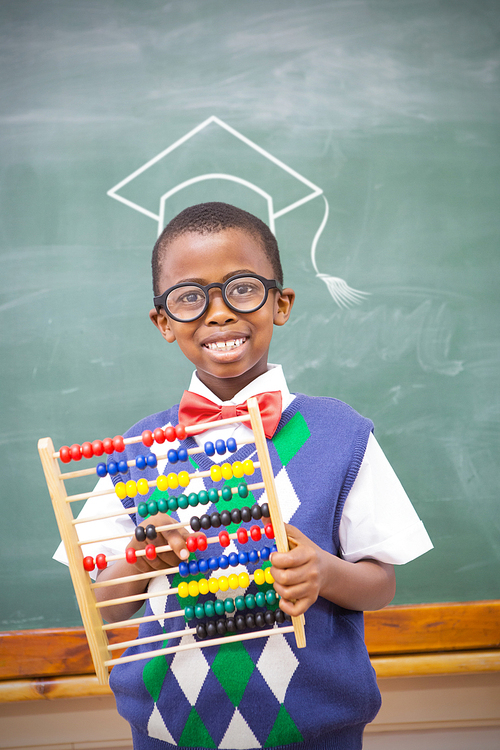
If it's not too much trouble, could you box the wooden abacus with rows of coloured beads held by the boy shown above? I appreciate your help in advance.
[38,398,306,684]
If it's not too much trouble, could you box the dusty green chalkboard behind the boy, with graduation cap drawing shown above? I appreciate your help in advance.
[0,0,500,630]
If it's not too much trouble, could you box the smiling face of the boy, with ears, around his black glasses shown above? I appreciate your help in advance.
[149,228,295,400]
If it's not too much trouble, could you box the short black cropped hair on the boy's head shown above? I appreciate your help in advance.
[151,203,283,295]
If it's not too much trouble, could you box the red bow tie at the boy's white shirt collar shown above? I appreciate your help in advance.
[179,391,281,440]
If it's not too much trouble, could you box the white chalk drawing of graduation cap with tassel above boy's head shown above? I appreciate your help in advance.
[107,115,369,307]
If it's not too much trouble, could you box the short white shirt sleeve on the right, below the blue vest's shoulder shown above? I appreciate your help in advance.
[339,435,433,565]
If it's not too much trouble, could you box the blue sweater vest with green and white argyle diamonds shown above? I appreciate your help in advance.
[110,394,380,750]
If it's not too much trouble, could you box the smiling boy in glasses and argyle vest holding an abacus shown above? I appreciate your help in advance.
[54,203,432,750]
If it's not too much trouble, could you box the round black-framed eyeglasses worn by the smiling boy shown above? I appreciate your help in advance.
[153,274,283,323]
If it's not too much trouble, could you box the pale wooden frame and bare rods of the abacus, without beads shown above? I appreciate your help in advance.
[38,398,306,684]
